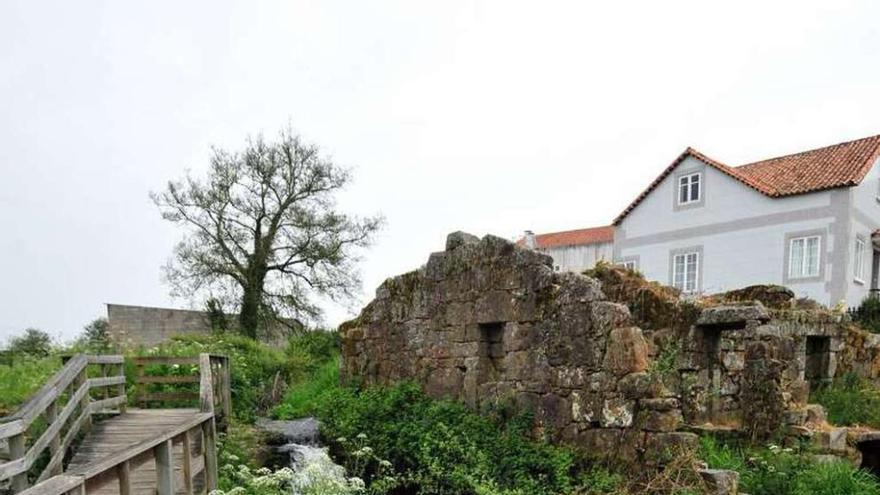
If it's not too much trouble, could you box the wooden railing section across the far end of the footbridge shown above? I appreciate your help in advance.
[130,354,232,431]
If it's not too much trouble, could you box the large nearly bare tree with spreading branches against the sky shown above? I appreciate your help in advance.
[151,128,382,337]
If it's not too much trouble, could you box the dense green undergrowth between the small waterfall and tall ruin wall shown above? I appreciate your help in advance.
[276,383,576,494]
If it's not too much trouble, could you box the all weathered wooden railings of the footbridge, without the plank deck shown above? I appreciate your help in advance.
[0,354,232,495]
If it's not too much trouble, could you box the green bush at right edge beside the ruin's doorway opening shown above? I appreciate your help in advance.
[810,373,880,427]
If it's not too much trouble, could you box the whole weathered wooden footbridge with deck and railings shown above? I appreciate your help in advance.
[0,354,231,495]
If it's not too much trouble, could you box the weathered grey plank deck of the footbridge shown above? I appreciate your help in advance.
[66,409,204,495]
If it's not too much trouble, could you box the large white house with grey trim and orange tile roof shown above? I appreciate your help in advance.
[613,136,880,306]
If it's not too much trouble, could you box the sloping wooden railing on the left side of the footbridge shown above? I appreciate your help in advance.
[0,354,127,493]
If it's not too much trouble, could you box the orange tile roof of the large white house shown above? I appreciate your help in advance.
[614,135,880,225]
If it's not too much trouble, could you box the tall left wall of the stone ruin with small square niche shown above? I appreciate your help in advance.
[340,232,697,463]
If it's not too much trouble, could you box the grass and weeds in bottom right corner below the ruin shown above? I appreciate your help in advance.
[700,437,880,495]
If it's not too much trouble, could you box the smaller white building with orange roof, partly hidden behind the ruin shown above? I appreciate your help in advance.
[519,225,614,272]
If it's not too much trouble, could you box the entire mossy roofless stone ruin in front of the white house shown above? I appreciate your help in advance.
[340,232,880,484]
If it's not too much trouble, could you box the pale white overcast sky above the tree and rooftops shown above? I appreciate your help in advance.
[0,0,880,340]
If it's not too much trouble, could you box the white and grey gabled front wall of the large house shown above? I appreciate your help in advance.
[614,157,848,305]
